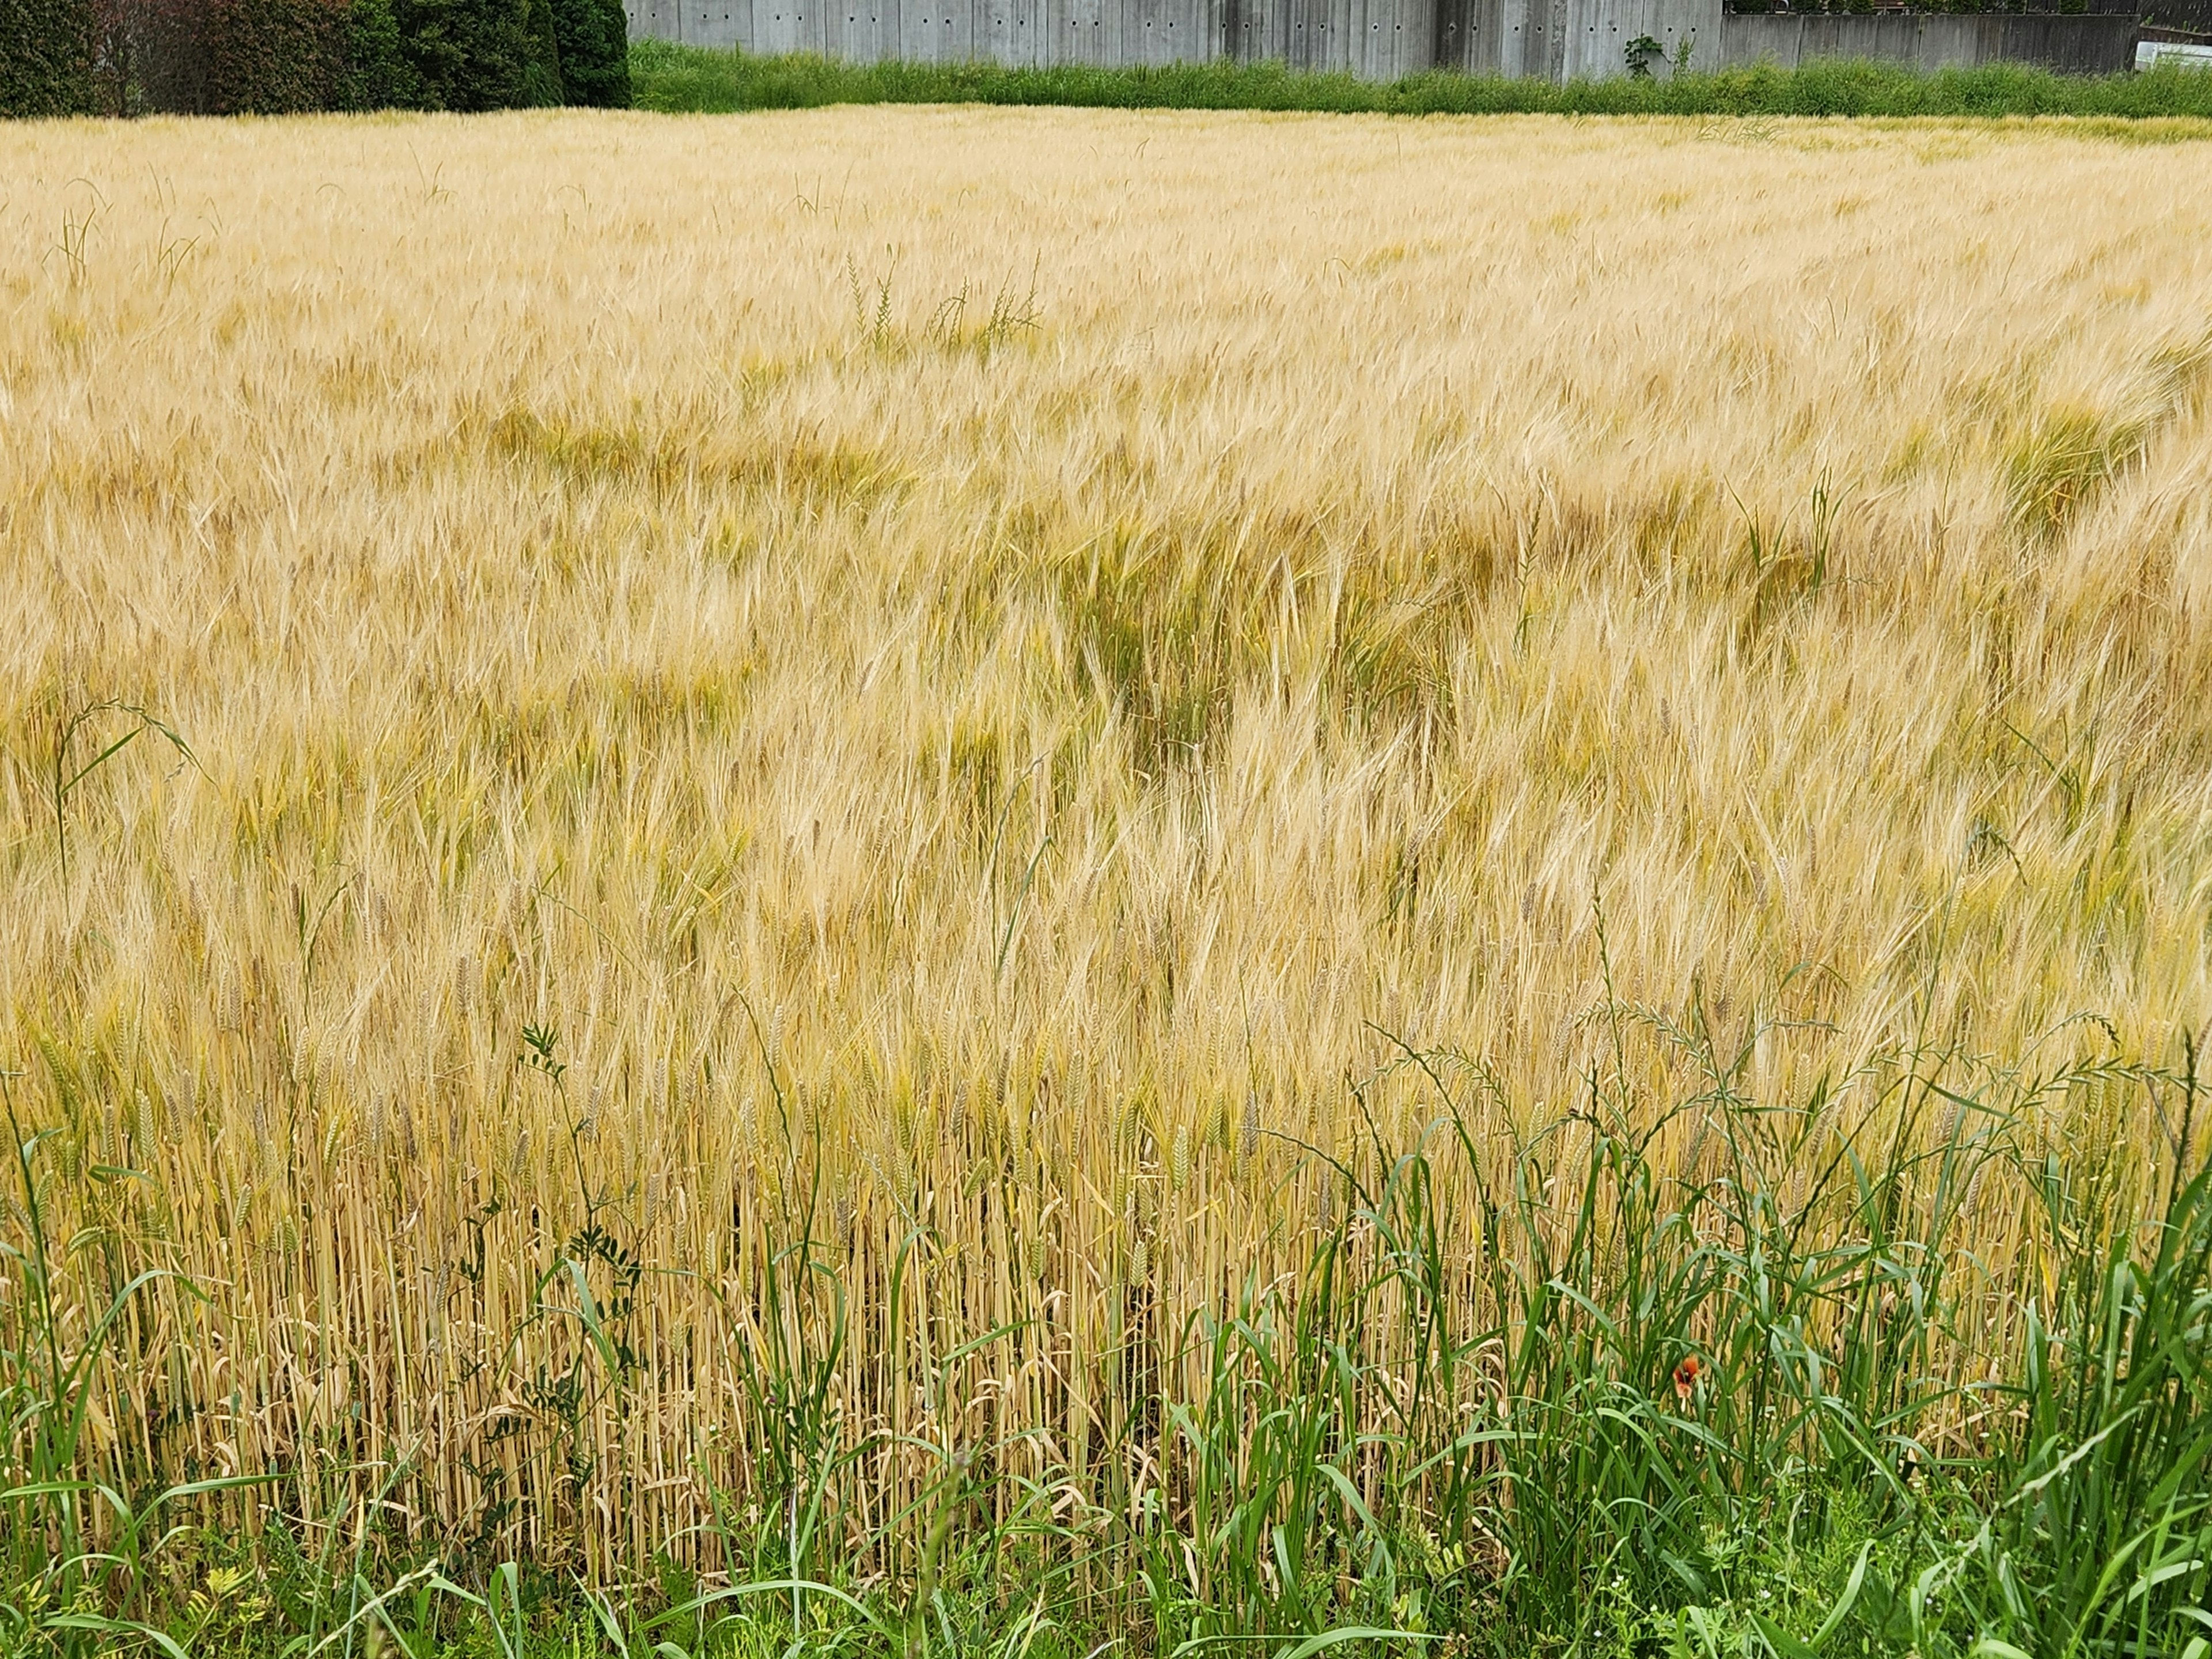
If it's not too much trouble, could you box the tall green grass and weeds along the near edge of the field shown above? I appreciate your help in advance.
[13,1035,2212,1659]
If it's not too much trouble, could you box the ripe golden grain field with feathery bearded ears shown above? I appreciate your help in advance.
[0,108,2212,1562]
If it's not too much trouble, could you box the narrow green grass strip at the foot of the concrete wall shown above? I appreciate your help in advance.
[630,40,2212,119]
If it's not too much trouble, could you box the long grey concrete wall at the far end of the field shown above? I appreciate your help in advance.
[626,0,2135,82]
